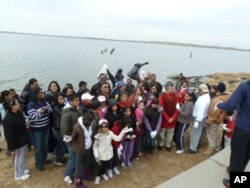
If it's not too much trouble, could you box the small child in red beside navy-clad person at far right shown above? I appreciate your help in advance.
[223,111,237,147]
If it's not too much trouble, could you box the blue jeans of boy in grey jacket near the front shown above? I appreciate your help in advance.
[64,144,76,177]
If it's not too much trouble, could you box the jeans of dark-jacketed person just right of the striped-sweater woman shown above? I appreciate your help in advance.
[52,128,67,162]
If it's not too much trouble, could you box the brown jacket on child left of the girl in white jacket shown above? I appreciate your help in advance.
[71,118,97,154]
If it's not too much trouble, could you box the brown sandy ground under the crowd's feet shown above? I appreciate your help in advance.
[0,125,215,188]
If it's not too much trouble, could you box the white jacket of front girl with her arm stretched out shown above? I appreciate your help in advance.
[93,131,125,161]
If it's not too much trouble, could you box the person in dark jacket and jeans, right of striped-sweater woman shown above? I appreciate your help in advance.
[52,94,67,166]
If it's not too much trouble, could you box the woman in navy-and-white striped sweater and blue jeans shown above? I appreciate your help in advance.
[28,87,52,171]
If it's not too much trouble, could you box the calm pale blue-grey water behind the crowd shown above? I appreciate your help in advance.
[0,33,250,92]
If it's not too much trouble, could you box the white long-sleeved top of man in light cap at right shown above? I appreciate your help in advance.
[193,93,211,122]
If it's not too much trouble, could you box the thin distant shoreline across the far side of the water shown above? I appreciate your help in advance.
[0,31,250,52]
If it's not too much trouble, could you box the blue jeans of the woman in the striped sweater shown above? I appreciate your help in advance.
[31,128,49,170]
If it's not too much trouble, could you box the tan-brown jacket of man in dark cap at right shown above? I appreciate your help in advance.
[206,94,228,125]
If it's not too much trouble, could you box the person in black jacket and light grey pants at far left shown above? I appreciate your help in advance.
[3,99,30,180]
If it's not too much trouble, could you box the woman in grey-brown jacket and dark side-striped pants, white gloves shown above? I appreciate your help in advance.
[175,93,195,154]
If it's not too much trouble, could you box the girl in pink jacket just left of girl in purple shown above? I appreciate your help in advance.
[134,100,145,160]
